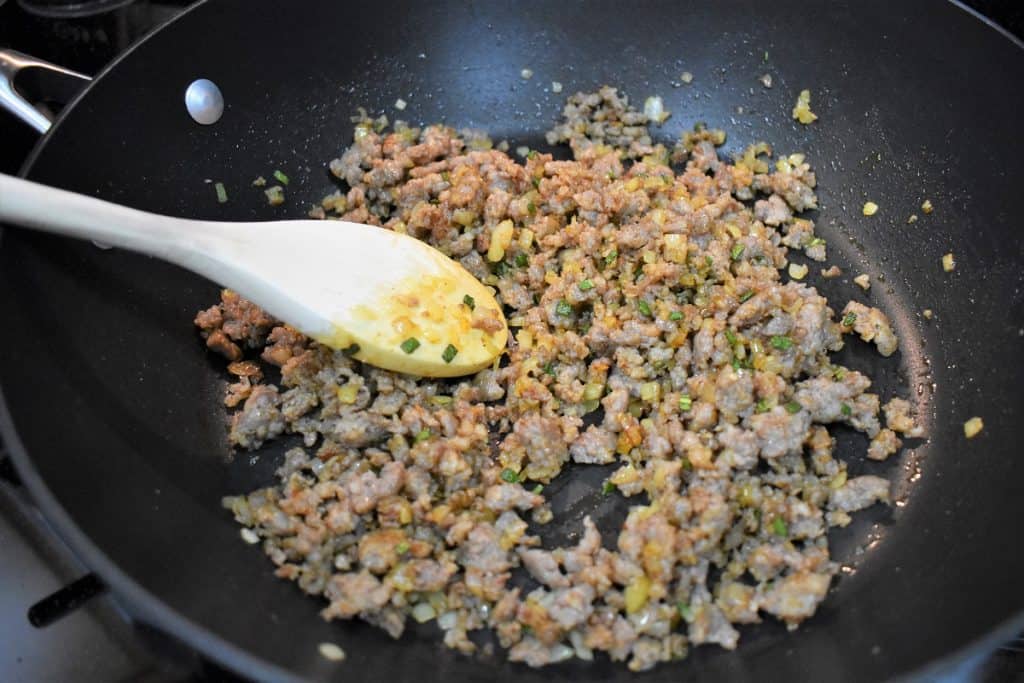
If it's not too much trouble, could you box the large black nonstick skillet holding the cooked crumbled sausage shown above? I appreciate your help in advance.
[0,0,1024,682]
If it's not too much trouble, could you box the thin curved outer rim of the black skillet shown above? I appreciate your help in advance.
[0,0,1024,683]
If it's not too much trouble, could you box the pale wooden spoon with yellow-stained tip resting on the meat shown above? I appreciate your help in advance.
[0,174,508,377]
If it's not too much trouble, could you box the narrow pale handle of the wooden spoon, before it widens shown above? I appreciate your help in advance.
[0,173,204,263]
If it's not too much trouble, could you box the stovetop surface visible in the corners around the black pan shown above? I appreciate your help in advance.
[0,0,1024,683]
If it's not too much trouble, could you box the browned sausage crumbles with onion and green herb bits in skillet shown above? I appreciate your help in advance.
[196,88,921,671]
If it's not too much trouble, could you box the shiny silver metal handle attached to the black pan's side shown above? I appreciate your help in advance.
[0,50,92,134]
